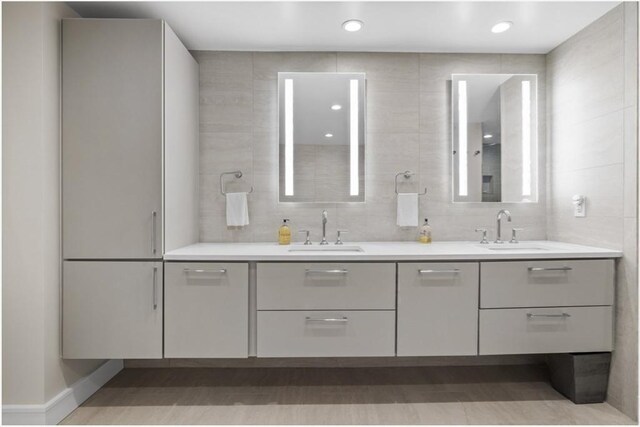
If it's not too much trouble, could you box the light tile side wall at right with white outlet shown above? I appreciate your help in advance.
[547,2,638,419]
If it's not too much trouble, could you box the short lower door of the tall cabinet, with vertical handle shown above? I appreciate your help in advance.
[62,261,162,359]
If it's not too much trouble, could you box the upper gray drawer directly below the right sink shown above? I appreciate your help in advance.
[480,259,614,308]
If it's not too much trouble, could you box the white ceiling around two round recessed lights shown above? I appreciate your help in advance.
[68,1,619,53]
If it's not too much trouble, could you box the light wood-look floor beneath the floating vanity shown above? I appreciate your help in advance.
[62,365,636,424]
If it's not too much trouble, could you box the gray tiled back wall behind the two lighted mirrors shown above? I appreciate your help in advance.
[193,51,546,242]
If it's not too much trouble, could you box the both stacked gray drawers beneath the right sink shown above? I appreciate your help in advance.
[479,259,614,354]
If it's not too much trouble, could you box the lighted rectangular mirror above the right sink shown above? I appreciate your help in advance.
[451,74,538,203]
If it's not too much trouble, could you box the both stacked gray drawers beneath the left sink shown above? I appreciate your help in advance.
[257,262,396,357]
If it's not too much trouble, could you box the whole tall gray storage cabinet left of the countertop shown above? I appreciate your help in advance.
[62,19,199,358]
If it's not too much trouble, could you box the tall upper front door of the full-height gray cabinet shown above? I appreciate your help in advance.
[62,19,163,259]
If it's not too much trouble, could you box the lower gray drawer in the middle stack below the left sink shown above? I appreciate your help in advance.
[258,310,395,357]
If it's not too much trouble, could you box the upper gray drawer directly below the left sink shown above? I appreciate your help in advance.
[257,262,396,310]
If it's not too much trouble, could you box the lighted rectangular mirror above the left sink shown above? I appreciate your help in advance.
[278,73,366,203]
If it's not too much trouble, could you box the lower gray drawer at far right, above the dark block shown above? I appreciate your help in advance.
[480,307,613,355]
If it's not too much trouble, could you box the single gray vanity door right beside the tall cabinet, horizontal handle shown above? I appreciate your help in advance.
[164,263,249,358]
